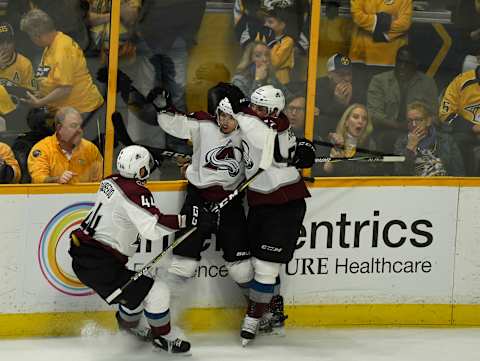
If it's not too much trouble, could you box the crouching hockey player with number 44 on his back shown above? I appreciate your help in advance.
[69,145,213,354]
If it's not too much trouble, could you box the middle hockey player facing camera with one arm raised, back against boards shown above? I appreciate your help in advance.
[145,89,253,304]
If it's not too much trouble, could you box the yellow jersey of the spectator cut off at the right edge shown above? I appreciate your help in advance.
[439,67,480,124]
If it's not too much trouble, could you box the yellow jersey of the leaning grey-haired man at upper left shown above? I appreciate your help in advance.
[35,31,103,113]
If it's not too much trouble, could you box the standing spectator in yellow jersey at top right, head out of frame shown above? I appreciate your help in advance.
[349,0,413,91]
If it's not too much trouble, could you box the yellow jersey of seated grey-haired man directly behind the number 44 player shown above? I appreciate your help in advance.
[28,134,103,183]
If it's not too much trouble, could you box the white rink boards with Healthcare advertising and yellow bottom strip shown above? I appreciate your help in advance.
[0,178,480,337]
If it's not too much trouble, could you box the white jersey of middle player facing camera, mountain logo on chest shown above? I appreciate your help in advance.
[157,112,248,202]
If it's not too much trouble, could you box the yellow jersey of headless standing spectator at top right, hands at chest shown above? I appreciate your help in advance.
[349,0,413,66]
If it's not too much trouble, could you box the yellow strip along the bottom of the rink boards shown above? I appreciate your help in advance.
[0,304,480,338]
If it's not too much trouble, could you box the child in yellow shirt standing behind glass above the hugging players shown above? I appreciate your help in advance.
[265,7,295,84]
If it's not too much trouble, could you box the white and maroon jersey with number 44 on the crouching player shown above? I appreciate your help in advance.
[80,175,183,257]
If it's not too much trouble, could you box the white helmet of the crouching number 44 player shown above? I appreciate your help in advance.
[117,145,154,181]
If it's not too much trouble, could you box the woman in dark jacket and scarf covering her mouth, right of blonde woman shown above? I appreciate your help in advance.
[395,102,465,177]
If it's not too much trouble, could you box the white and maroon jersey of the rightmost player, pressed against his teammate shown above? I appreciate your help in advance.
[235,108,310,206]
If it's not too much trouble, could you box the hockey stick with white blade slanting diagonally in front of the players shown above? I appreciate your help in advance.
[105,131,275,304]
